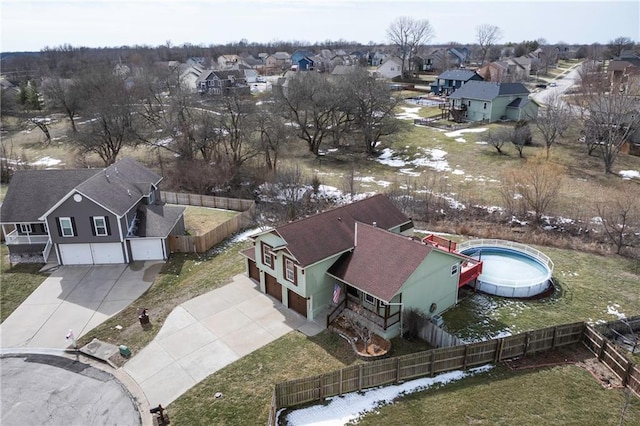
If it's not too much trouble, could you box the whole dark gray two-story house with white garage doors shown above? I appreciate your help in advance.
[0,158,184,265]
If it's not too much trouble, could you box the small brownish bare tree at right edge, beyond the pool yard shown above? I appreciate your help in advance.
[595,187,640,254]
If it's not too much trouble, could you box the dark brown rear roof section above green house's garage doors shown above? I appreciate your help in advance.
[272,194,410,267]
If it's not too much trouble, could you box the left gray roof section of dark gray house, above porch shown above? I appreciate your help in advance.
[0,169,100,223]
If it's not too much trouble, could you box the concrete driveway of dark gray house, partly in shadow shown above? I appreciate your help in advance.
[0,262,162,348]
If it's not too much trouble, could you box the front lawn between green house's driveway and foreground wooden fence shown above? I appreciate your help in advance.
[168,331,429,425]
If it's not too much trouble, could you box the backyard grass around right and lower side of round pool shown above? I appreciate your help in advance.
[443,247,640,339]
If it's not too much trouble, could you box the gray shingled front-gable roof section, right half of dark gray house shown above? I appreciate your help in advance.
[76,158,162,216]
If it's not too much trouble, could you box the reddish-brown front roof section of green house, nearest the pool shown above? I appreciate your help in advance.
[328,223,433,302]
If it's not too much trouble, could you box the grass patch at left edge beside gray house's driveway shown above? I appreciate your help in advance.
[0,244,47,322]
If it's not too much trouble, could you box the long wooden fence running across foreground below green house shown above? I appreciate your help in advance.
[269,322,585,418]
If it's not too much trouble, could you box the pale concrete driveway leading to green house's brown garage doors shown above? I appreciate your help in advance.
[123,275,323,406]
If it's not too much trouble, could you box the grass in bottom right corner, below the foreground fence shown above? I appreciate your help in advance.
[350,366,640,426]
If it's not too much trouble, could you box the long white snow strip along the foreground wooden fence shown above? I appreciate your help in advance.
[278,365,493,426]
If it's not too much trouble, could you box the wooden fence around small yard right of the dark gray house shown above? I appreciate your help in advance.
[162,191,256,253]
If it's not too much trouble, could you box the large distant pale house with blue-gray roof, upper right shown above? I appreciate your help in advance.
[449,81,539,122]
